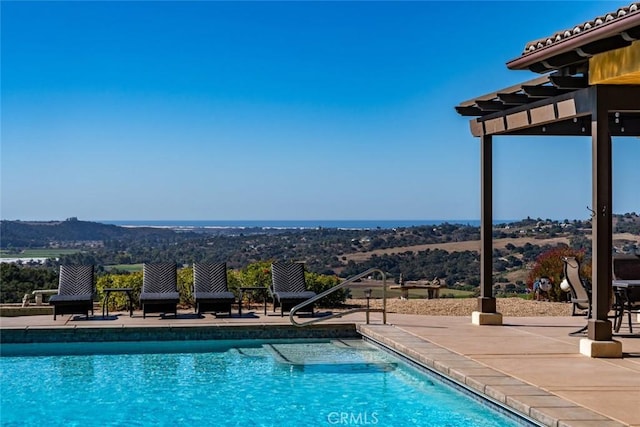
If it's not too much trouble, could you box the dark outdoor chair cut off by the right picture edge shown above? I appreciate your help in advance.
[613,255,640,333]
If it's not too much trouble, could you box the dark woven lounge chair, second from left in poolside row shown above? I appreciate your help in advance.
[140,263,180,318]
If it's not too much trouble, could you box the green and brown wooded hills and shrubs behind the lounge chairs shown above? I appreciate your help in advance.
[0,213,640,304]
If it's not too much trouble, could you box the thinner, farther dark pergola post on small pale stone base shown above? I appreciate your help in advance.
[471,135,502,325]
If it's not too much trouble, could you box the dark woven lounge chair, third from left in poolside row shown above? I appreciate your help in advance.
[193,262,236,316]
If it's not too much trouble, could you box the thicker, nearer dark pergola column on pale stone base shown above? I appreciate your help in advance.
[580,93,622,357]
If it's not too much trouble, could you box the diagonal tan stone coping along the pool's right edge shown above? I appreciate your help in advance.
[357,324,625,427]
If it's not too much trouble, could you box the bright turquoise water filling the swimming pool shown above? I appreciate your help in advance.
[0,340,521,427]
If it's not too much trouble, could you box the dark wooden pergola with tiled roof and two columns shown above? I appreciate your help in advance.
[456,3,640,357]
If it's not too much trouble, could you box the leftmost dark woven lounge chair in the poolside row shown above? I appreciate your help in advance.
[49,265,95,320]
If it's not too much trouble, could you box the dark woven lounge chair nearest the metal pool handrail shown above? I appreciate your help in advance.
[270,262,316,316]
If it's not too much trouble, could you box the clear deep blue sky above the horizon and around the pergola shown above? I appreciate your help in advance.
[0,1,640,220]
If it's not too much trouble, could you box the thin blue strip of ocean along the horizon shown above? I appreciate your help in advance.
[97,219,515,230]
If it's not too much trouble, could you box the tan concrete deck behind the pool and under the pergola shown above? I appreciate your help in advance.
[0,308,640,427]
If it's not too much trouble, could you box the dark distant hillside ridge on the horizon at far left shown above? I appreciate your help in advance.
[0,218,176,249]
